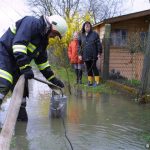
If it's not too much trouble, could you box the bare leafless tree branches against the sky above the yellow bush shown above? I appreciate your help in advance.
[27,0,134,23]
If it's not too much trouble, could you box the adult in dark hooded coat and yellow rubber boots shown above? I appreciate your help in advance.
[78,21,102,86]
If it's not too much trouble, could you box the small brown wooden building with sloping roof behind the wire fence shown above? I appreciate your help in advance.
[93,9,150,80]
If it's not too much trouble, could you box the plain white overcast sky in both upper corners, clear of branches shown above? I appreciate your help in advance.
[0,0,150,36]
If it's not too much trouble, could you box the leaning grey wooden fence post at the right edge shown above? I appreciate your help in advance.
[140,23,150,95]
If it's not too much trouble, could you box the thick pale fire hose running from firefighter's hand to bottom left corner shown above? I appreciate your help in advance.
[0,75,25,150]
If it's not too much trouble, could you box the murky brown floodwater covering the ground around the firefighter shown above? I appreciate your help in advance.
[0,73,150,150]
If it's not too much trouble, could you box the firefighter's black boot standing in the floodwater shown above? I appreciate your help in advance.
[17,98,28,122]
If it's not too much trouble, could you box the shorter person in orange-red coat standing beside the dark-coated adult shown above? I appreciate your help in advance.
[68,32,83,84]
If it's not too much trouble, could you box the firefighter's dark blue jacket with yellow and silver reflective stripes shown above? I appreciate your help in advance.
[0,16,54,86]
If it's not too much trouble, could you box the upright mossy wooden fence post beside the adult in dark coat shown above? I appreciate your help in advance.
[103,24,111,80]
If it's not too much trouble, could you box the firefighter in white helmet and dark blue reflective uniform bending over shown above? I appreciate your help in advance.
[0,15,67,120]
